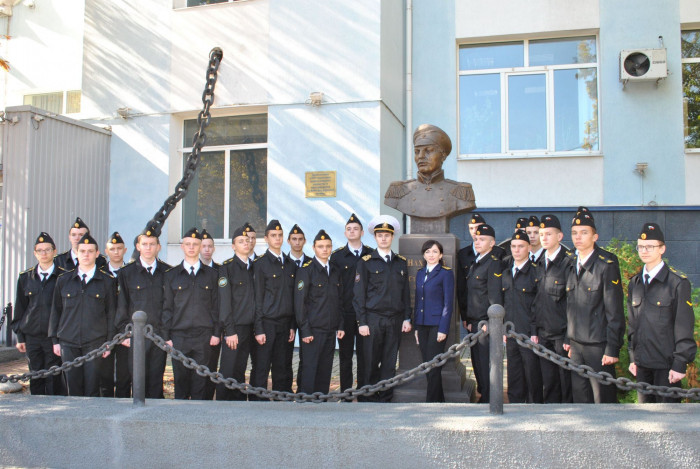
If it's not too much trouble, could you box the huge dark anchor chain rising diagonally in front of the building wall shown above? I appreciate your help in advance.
[146,47,224,233]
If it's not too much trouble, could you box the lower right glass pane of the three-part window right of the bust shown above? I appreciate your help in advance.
[554,68,598,151]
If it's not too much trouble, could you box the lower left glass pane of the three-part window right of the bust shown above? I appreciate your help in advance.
[459,74,501,154]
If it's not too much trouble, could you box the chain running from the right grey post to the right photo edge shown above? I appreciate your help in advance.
[505,321,700,401]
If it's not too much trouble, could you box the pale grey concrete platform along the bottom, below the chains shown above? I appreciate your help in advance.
[0,395,700,468]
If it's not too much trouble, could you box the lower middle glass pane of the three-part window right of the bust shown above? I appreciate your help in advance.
[508,73,547,150]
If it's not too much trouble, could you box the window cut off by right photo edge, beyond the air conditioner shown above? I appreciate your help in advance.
[681,30,700,149]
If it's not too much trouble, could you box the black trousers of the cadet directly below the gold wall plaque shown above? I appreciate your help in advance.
[297,329,335,394]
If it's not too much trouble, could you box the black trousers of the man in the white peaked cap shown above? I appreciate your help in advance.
[362,313,403,402]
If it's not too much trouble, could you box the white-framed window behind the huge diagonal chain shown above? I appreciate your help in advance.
[182,114,267,239]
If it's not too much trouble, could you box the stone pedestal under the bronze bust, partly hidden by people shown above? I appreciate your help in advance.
[393,233,474,402]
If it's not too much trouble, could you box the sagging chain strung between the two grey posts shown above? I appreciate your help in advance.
[145,321,488,403]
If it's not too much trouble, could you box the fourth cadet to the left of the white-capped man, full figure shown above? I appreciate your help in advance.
[250,220,297,392]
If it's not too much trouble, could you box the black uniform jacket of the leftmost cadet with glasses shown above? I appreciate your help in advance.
[12,259,65,343]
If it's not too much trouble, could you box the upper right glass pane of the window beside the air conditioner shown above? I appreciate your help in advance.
[529,38,597,67]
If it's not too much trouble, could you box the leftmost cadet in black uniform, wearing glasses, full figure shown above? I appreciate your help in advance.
[11,231,65,396]
